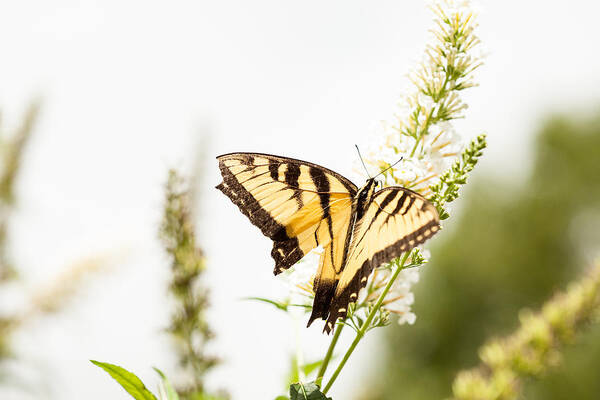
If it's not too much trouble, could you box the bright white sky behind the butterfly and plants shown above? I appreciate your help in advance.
[0,0,600,400]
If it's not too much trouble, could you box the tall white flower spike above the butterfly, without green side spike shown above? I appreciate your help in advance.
[365,0,481,195]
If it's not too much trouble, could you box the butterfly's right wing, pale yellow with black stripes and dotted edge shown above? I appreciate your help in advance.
[325,186,440,332]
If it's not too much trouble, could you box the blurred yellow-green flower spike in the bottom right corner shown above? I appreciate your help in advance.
[452,261,600,400]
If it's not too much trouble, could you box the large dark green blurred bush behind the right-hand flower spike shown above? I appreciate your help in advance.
[364,110,600,400]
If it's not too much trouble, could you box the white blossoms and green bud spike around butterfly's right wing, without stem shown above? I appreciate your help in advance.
[354,0,485,323]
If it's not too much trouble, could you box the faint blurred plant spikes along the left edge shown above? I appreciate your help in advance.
[0,100,107,396]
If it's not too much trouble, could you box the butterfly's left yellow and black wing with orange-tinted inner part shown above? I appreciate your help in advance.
[217,153,357,310]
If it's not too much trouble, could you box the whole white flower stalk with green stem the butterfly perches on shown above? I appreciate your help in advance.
[317,0,486,394]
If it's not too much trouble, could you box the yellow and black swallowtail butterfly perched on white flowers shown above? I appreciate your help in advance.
[216,153,440,333]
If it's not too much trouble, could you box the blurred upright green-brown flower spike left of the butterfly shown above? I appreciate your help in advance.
[160,170,229,400]
